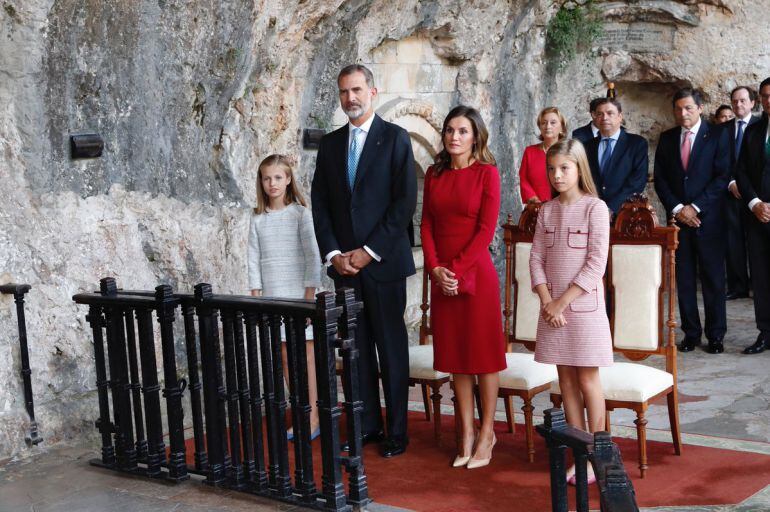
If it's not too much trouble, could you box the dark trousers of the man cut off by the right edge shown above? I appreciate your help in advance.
[746,218,770,339]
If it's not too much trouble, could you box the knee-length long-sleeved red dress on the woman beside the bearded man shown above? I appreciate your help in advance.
[420,163,506,374]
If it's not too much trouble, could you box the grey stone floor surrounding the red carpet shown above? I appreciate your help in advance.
[0,300,770,512]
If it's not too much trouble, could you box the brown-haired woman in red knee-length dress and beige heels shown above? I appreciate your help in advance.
[420,105,506,469]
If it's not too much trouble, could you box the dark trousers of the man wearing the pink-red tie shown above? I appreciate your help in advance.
[676,226,727,340]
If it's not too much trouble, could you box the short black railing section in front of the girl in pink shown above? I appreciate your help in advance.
[536,409,639,512]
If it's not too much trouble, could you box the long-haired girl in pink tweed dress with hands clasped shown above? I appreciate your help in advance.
[529,139,612,479]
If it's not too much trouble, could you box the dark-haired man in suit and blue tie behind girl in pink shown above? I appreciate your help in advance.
[585,98,649,213]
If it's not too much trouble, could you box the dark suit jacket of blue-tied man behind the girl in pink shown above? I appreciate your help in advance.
[585,130,649,213]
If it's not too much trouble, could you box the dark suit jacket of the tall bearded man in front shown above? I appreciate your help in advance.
[311,115,417,281]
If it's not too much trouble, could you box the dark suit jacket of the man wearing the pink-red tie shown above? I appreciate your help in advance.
[654,121,728,235]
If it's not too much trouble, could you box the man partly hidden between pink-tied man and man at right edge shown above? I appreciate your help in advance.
[722,85,759,300]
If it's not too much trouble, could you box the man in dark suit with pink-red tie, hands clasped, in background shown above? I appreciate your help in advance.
[655,88,729,354]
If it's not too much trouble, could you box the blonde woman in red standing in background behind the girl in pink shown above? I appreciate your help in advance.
[519,107,567,204]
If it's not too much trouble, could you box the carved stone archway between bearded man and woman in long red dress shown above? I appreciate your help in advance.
[377,98,443,246]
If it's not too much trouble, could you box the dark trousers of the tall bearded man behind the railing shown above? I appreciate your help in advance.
[335,270,409,437]
